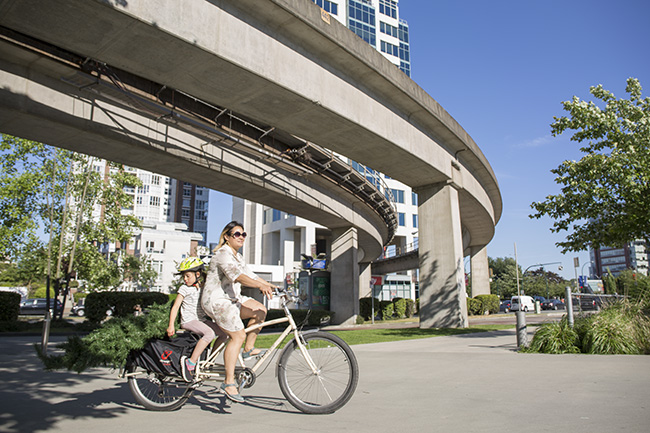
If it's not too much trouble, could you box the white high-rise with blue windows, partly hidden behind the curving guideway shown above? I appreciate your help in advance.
[233,0,418,299]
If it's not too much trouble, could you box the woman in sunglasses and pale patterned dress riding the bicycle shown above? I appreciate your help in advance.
[201,221,276,403]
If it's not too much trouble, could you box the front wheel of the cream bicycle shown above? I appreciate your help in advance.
[278,331,359,414]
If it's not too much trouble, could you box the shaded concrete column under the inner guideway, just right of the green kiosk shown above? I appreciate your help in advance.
[330,227,359,325]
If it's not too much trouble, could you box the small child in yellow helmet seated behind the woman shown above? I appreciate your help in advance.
[167,257,226,382]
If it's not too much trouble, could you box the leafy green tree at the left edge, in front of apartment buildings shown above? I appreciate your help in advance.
[0,135,141,288]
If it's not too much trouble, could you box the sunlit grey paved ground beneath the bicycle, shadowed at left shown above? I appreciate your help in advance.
[0,328,650,433]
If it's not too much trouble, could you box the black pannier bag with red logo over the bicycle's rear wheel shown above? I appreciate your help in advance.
[127,332,198,377]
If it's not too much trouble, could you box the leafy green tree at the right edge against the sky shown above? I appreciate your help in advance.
[530,78,650,252]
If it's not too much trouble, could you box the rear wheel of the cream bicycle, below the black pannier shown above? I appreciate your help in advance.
[126,363,194,411]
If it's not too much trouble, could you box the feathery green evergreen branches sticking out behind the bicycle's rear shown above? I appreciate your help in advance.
[35,303,171,373]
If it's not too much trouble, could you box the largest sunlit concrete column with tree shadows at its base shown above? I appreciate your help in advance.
[417,183,468,328]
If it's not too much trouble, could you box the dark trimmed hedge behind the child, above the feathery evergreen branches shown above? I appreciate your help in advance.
[85,292,169,323]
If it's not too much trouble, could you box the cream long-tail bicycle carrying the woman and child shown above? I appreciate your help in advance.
[124,290,359,414]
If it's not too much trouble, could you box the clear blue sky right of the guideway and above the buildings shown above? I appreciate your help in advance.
[208,0,650,278]
